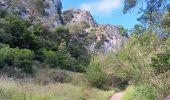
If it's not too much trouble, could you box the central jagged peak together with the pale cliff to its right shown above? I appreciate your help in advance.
[62,9,126,53]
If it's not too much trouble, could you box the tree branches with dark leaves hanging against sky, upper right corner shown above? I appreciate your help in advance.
[123,0,169,25]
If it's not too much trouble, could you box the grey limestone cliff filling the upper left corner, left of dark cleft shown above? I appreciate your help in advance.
[0,0,63,27]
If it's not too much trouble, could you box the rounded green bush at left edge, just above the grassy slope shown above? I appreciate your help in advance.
[0,47,34,73]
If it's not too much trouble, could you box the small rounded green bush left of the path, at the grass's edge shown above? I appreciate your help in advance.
[86,60,107,88]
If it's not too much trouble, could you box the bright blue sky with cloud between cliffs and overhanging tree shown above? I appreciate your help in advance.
[61,0,140,29]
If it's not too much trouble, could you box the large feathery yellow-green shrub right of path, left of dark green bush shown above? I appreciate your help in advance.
[109,30,167,84]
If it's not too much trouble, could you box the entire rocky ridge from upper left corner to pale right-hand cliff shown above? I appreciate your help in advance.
[0,0,125,53]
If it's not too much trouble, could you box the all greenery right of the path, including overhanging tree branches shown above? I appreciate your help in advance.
[111,0,170,100]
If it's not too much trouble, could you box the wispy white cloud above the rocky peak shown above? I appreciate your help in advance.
[80,0,122,17]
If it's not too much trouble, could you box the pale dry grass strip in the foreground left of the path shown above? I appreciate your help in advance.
[0,79,114,100]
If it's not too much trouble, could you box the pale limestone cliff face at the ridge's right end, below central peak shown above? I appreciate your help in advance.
[89,24,125,53]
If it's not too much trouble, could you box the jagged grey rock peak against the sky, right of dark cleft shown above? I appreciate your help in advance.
[62,9,97,27]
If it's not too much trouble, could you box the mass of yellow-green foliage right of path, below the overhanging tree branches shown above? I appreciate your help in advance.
[108,30,170,97]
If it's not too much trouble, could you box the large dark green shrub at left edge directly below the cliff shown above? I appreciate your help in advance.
[0,18,41,50]
